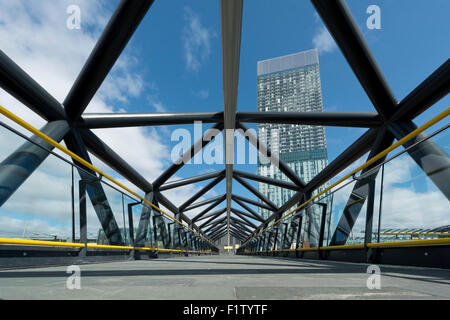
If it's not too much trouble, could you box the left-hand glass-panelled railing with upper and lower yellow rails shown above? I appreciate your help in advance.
[0,106,217,253]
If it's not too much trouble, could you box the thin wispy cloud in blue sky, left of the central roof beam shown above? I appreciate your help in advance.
[182,7,216,72]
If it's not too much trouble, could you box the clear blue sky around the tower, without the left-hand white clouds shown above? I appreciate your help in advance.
[123,0,450,208]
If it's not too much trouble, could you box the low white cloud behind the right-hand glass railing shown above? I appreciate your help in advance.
[333,154,450,236]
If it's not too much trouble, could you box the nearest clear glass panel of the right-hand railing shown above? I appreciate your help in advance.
[380,130,450,242]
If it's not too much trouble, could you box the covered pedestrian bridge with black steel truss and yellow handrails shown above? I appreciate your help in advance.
[0,0,450,299]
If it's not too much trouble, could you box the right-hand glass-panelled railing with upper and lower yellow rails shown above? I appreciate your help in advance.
[239,108,450,253]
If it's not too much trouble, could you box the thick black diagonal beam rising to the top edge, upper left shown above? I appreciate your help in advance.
[63,0,153,121]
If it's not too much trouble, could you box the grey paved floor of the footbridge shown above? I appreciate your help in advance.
[0,255,450,300]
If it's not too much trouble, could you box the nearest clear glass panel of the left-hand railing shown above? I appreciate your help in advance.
[0,126,73,242]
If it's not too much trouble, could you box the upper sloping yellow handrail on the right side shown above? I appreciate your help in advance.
[255,108,450,238]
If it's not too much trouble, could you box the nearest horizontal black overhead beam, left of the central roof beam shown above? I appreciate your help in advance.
[80,112,223,129]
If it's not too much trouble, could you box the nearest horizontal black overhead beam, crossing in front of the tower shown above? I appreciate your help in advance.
[236,112,382,128]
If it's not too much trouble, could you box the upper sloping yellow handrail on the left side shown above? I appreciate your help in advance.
[0,106,211,243]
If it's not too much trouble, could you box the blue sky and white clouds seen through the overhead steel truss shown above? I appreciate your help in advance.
[0,0,450,239]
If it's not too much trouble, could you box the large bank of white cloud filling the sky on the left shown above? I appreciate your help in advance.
[0,0,216,240]
